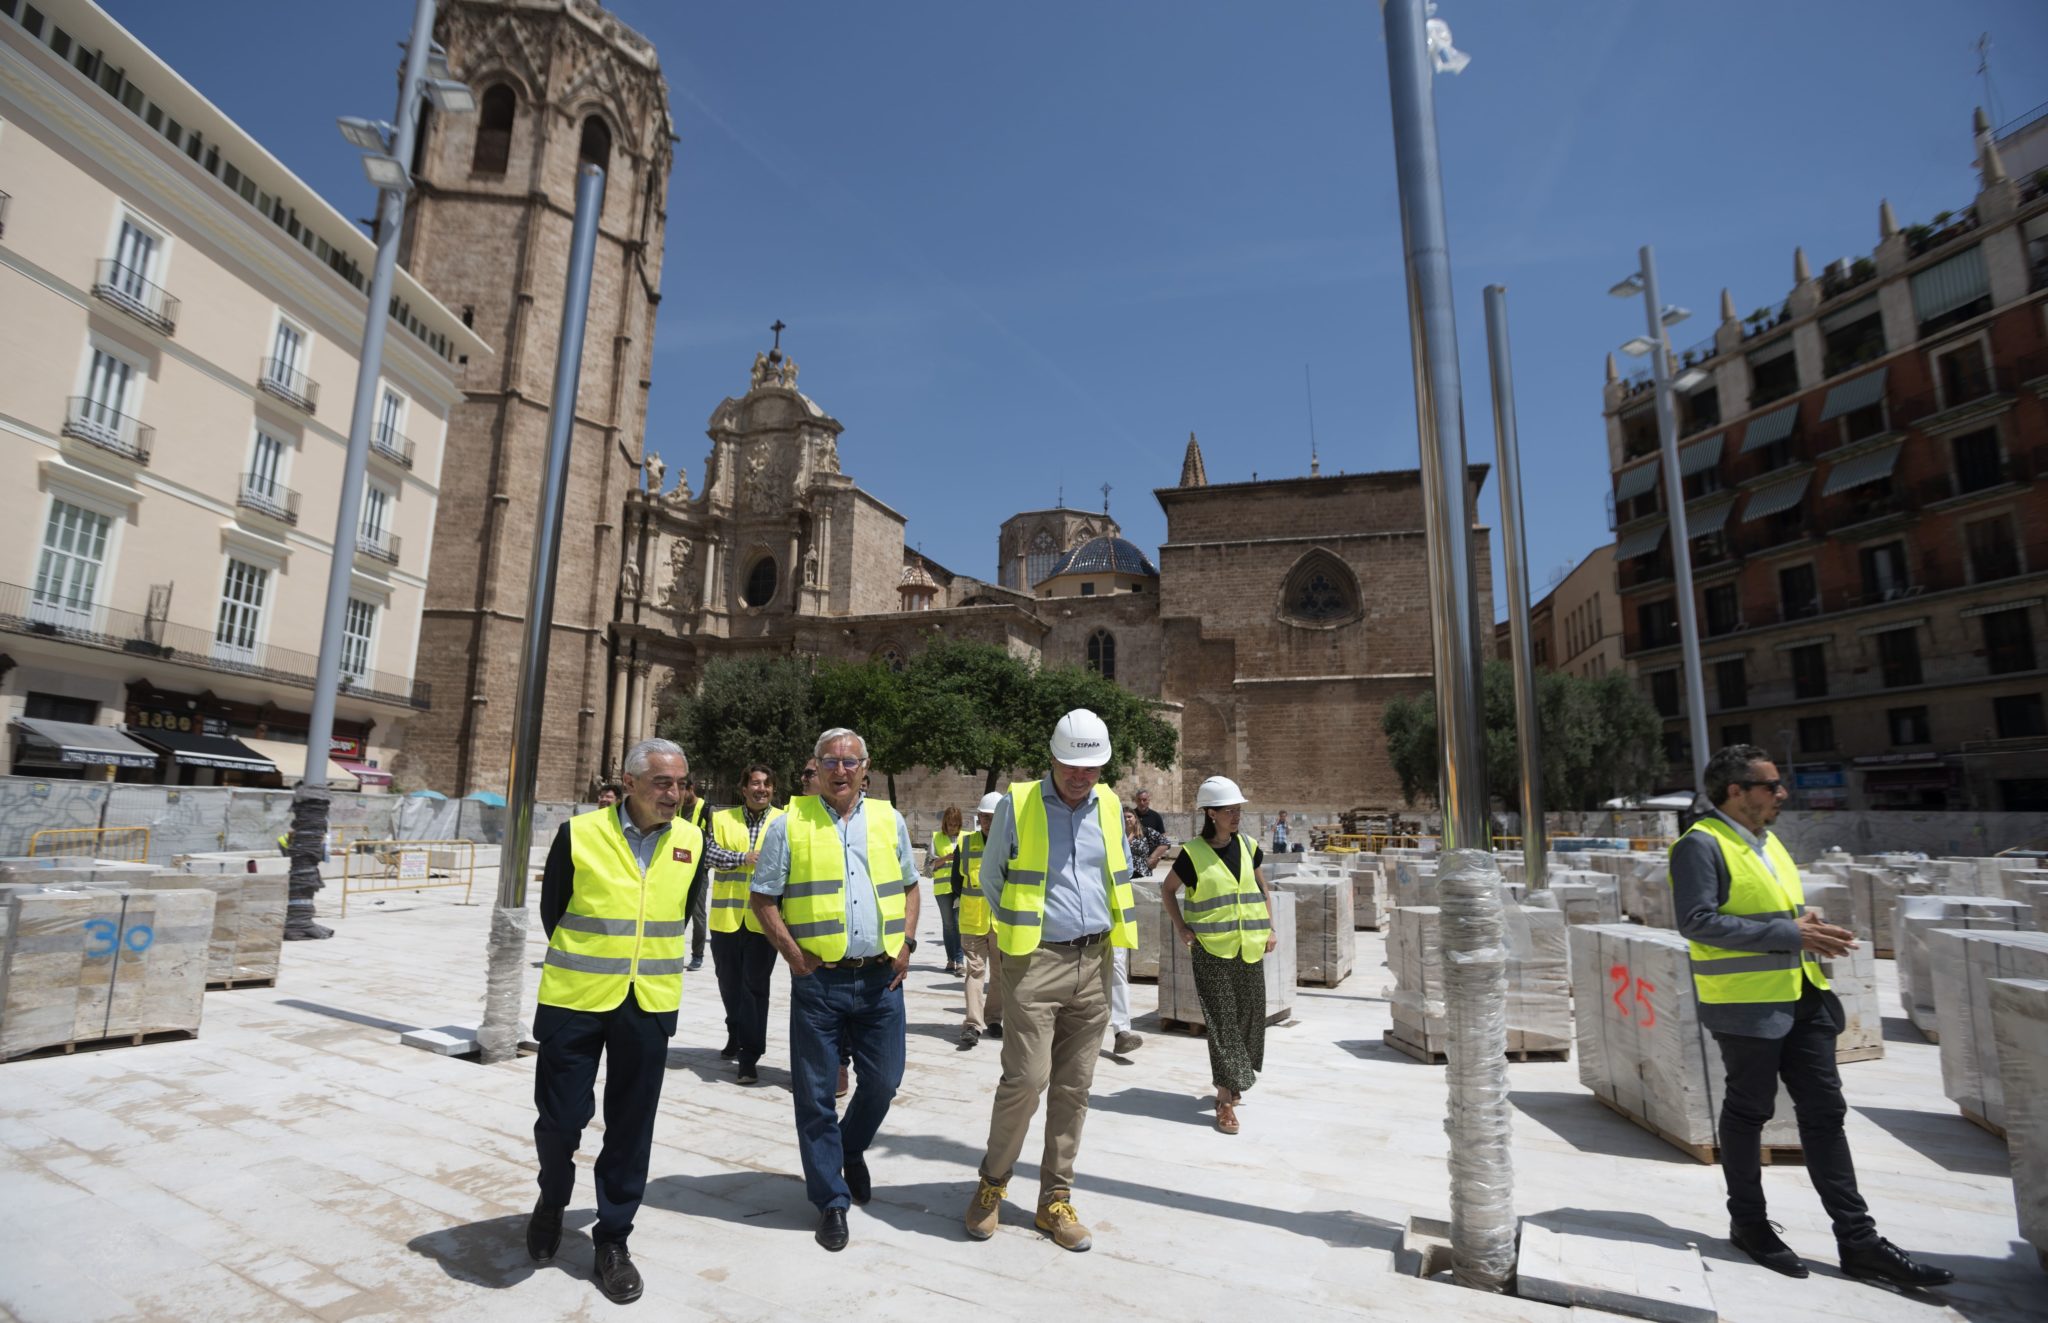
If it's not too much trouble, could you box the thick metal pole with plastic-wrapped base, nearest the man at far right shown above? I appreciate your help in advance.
[1380,0,1516,1290]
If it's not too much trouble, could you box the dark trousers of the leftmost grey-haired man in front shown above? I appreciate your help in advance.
[532,991,670,1245]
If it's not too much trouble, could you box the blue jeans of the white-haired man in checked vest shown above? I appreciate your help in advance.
[788,965,903,1210]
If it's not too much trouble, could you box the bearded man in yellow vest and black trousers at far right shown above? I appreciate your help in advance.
[1671,743,1956,1288]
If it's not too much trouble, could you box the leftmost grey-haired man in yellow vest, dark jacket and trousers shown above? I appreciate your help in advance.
[526,739,705,1305]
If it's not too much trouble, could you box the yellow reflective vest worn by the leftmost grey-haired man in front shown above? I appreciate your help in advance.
[541,809,705,1012]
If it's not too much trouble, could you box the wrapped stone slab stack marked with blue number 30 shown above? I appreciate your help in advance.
[0,887,213,1061]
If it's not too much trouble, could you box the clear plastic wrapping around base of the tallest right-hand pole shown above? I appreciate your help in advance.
[1436,850,1516,1290]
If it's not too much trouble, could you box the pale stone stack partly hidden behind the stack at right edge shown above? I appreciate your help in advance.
[1927,928,2048,1133]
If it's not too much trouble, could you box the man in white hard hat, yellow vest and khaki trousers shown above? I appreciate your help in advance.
[965,709,1139,1251]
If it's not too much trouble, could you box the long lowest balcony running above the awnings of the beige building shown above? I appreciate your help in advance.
[0,584,432,709]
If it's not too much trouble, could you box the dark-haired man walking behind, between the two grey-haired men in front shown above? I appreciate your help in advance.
[711,762,782,1083]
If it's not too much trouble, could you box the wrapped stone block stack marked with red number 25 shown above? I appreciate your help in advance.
[1571,924,1798,1159]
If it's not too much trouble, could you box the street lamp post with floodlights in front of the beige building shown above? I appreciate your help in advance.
[285,0,434,940]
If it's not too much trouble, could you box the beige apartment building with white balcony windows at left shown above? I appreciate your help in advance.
[0,0,489,788]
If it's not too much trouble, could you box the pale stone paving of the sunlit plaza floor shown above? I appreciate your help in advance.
[0,885,2048,1323]
